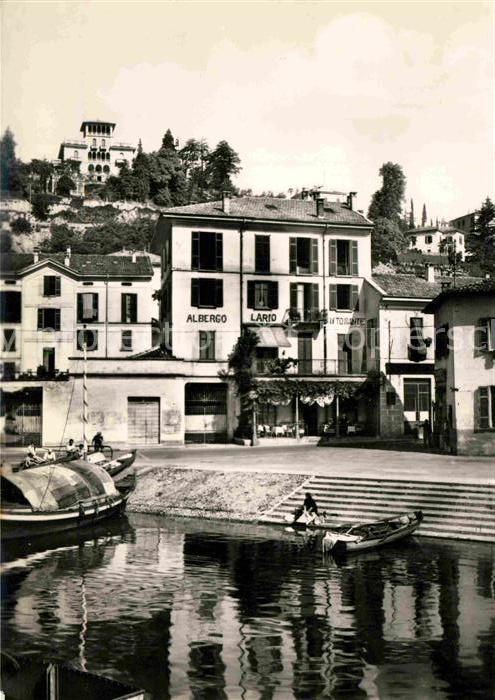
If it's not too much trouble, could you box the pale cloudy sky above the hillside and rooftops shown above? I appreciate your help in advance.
[1,0,495,220]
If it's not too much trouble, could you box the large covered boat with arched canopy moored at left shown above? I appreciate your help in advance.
[0,460,132,539]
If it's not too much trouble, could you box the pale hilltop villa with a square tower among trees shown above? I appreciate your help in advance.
[53,119,136,194]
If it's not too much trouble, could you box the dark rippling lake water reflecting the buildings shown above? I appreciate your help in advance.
[2,515,495,700]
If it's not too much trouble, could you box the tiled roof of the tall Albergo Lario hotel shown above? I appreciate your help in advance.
[162,197,372,226]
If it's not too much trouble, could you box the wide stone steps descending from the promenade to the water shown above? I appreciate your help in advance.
[260,475,495,543]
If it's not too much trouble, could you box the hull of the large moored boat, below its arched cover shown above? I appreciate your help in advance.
[0,494,129,539]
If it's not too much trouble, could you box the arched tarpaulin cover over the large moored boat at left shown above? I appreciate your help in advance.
[2,461,118,511]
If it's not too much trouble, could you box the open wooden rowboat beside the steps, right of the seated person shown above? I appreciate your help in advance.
[322,510,423,555]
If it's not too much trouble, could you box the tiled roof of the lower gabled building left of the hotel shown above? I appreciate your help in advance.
[0,253,153,277]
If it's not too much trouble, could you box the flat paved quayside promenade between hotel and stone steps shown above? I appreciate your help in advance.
[137,445,495,485]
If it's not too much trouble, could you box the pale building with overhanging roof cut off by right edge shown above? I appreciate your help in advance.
[424,280,495,455]
